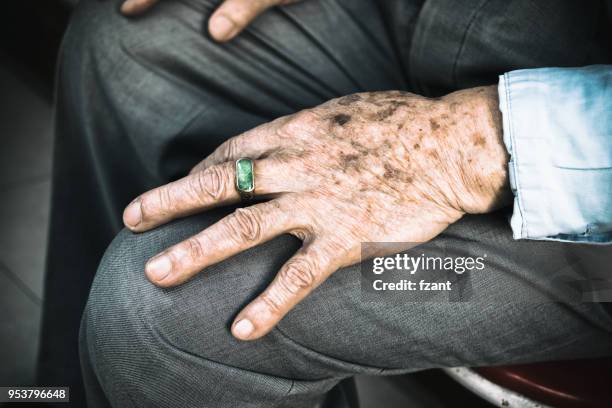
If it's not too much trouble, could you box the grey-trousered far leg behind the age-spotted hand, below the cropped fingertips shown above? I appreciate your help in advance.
[40,0,403,400]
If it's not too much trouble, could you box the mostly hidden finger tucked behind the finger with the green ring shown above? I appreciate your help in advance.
[189,117,287,174]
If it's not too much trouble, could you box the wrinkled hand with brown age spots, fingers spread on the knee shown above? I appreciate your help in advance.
[124,86,511,340]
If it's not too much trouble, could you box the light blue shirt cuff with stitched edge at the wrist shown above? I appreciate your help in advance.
[499,65,612,243]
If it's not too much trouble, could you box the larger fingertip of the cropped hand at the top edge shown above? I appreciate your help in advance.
[208,0,279,42]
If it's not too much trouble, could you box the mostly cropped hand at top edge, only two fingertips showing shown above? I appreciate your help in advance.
[121,0,300,42]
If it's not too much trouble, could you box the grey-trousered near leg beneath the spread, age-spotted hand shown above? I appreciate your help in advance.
[81,210,612,407]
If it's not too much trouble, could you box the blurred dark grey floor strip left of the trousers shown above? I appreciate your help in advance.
[0,55,52,385]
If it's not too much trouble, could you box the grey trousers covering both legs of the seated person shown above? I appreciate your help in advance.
[43,0,612,408]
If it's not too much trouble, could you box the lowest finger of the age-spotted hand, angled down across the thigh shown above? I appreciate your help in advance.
[232,242,338,340]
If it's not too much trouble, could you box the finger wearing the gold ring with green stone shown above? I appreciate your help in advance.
[123,159,283,232]
